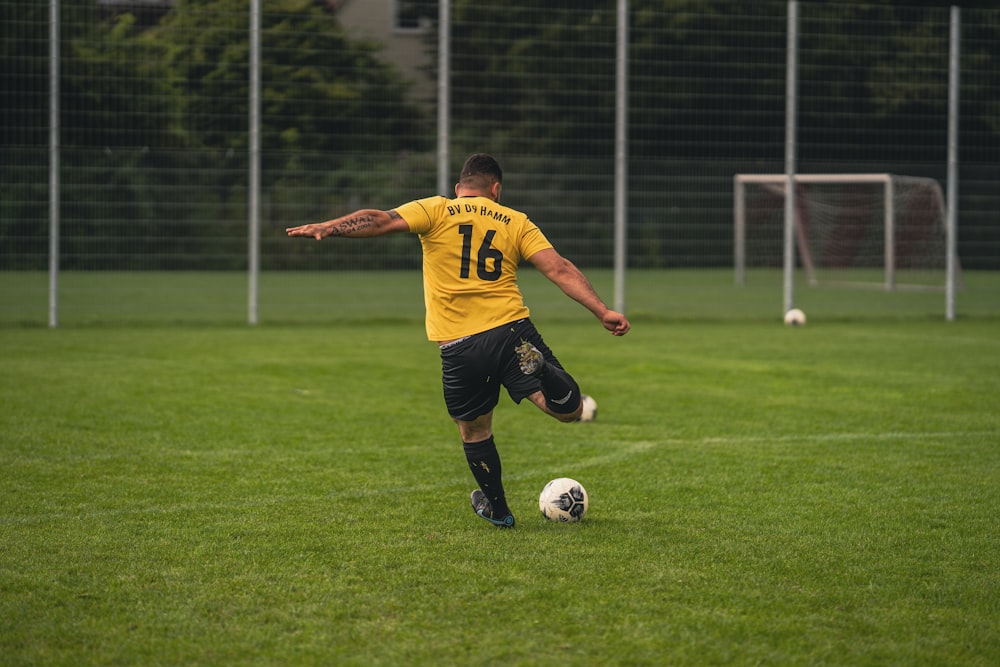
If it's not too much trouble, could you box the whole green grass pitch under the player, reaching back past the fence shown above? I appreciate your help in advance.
[0,274,1000,667]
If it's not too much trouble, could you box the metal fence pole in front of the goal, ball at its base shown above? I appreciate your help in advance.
[783,0,799,313]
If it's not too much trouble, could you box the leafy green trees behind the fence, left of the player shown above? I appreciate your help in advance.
[0,0,430,269]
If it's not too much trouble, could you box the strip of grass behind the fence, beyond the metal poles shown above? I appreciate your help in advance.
[0,269,1000,327]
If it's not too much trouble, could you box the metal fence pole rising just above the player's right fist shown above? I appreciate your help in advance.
[614,0,628,313]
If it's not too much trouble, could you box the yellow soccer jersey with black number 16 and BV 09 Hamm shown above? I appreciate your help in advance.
[396,197,552,341]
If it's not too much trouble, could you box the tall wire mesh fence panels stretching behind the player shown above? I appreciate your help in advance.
[0,0,1000,323]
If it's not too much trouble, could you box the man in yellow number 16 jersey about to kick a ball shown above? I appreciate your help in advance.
[285,153,631,528]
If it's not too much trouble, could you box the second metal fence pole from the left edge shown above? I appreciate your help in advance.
[247,0,260,325]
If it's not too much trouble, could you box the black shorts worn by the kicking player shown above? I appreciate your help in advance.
[441,318,562,421]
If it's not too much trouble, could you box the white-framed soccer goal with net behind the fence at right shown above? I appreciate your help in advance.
[733,174,960,290]
